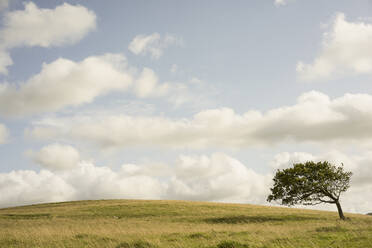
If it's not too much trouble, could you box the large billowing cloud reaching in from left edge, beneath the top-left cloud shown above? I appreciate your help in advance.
[0,50,201,117]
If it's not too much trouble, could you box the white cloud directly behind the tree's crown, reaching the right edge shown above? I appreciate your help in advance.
[272,150,372,213]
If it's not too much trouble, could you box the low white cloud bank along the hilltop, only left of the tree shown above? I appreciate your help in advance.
[0,151,268,207]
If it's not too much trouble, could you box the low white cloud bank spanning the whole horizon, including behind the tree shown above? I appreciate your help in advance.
[0,144,372,213]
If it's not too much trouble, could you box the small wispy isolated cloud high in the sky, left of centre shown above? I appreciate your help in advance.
[128,33,182,59]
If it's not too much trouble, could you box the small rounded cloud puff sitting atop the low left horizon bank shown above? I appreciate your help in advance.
[28,143,80,170]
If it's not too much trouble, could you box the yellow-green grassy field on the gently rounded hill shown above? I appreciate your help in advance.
[0,200,372,248]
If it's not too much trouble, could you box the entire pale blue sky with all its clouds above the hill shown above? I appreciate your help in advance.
[0,0,372,213]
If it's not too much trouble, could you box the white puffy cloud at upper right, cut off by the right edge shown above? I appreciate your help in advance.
[296,13,372,81]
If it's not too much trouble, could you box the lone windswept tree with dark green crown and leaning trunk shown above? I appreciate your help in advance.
[267,161,352,220]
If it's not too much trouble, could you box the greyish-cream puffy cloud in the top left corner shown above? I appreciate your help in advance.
[0,1,96,74]
